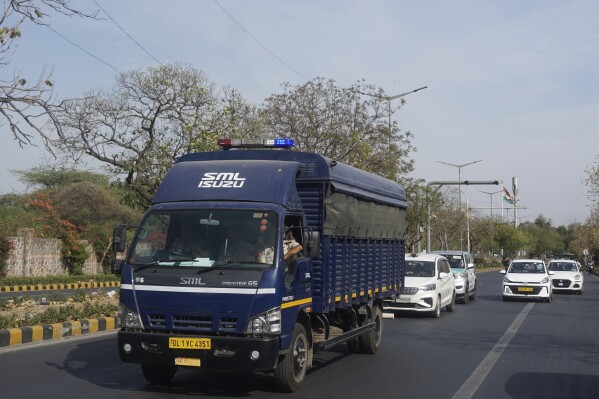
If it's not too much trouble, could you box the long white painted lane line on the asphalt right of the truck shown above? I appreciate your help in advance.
[451,302,535,399]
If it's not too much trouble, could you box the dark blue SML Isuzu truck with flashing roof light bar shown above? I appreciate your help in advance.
[113,139,407,392]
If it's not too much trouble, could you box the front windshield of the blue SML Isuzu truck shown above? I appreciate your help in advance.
[128,209,278,268]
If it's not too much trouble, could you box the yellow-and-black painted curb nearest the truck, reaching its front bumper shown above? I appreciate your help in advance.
[0,317,117,349]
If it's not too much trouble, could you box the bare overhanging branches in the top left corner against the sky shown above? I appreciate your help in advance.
[0,0,96,149]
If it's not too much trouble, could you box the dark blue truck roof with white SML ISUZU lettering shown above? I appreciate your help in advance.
[152,150,407,208]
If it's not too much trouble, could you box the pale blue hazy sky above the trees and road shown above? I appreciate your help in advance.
[0,0,599,226]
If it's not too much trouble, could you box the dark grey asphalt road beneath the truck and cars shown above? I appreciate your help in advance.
[0,272,599,399]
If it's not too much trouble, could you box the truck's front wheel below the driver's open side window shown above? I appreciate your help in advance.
[275,323,308,392]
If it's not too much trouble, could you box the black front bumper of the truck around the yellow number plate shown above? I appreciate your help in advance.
[118,330,279,371]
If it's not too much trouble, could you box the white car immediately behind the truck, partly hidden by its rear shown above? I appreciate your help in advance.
[383,254,456,317]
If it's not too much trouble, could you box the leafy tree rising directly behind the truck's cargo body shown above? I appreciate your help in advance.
[262,78,414,181]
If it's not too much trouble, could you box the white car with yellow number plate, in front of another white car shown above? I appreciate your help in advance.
[501,259,553,302]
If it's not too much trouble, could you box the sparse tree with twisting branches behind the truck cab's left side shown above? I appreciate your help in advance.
[57,64,260,208]
